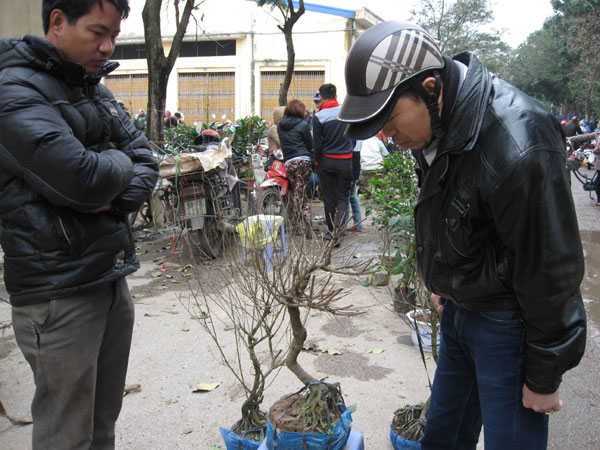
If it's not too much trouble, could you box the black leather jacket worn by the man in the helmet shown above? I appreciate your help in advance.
[415,53,586,393]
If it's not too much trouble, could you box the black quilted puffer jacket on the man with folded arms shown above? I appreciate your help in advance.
[0,36,158,306]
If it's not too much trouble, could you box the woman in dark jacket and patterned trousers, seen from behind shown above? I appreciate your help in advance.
[277,100,313,239]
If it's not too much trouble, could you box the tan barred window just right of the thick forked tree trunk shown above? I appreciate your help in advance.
[179,72,235,125]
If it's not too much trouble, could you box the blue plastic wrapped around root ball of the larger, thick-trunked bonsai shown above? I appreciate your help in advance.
[266,405,352,450]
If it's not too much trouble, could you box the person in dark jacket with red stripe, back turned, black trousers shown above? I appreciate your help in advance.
[312,84,355,239]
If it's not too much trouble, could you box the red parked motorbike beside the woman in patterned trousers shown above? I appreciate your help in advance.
[258,149,289,217]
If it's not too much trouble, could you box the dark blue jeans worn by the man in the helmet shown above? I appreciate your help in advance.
[421,301,548,450]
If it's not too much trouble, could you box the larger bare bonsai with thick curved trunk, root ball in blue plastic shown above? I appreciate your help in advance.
[256,230,372,450]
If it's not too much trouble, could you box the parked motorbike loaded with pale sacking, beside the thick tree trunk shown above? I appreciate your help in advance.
[160,130,243,258]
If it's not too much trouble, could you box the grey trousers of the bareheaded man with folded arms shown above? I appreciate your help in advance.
[12,279,134,450]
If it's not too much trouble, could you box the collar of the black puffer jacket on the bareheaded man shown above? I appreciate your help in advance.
[15,34,119,85]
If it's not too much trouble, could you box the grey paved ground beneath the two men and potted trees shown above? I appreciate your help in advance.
[0,169,600,450]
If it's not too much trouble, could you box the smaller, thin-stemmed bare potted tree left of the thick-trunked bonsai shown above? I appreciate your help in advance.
[191,246,286,450]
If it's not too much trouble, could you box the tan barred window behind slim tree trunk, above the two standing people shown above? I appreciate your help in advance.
[260,70,325,121]
